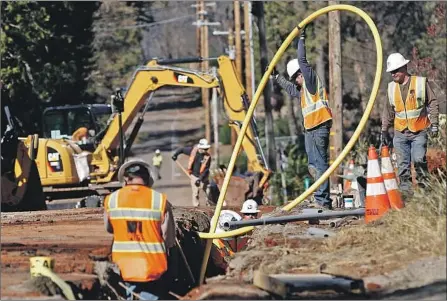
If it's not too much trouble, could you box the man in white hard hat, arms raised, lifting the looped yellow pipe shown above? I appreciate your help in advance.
[272,29,332,209]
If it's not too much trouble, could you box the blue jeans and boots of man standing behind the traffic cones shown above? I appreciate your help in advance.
[393,130,428,194]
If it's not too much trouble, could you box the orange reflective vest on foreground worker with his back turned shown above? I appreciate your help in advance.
[105,185,167,282]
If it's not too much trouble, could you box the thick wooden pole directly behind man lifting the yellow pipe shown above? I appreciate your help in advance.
[329,0,343,186]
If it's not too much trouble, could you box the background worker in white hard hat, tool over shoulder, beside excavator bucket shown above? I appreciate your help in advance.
[172,139,212,207]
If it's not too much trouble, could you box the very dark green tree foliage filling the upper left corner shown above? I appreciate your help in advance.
[1,1,99,132]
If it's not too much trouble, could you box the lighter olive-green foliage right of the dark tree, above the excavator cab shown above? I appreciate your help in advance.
[89,2,142,102]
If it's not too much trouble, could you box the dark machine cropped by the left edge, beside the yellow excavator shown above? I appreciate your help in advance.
[1,103,47,212]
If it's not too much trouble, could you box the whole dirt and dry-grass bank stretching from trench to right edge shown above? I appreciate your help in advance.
[232,170,447,281]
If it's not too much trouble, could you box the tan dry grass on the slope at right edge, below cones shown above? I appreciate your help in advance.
[326,170,447,256]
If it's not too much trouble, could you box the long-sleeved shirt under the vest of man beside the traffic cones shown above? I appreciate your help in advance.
[382,80,439,132]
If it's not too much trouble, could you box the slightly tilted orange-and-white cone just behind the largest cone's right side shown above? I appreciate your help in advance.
[381,146,404,209]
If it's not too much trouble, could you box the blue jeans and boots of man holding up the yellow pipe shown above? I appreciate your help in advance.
[304,123,332,206]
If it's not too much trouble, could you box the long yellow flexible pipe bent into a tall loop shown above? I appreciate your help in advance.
[199,4,382,284]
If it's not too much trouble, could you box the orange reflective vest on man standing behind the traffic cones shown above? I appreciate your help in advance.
[388,76,430,132]
